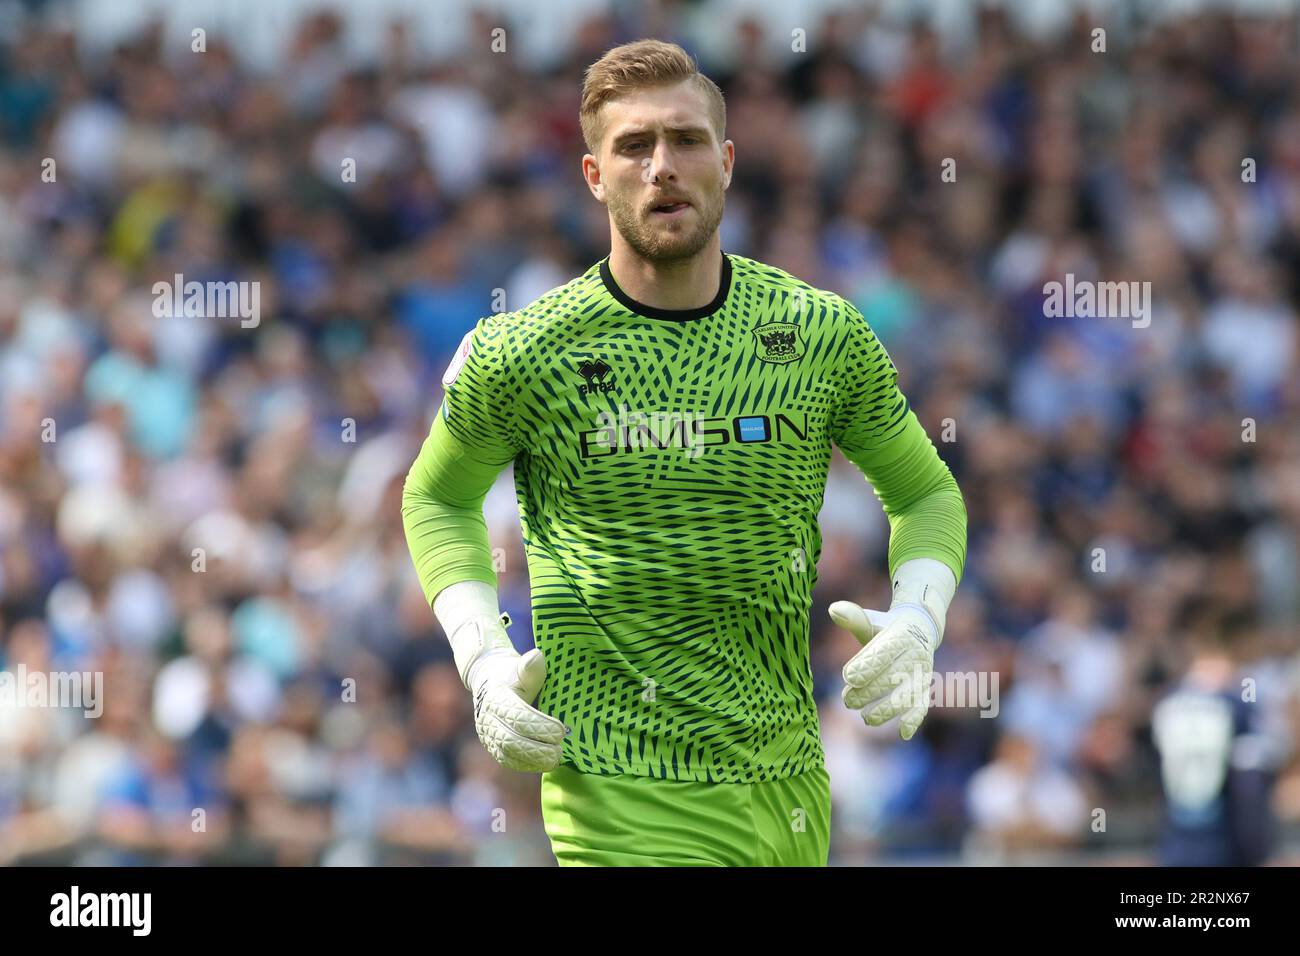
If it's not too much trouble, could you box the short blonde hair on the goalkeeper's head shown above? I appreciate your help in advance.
[579,40,727,153]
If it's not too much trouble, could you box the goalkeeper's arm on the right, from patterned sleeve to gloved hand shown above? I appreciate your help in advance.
[829,303,966,740]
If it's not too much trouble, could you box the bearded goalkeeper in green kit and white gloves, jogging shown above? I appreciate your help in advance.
[402,40,966,866]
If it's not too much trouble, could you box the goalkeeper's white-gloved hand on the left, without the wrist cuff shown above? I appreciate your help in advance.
[456,618,568,773]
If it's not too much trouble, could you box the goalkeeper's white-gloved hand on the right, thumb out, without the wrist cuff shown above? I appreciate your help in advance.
[831,601,941,740]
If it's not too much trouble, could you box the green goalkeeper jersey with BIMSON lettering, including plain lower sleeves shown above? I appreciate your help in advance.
[403,254,966,783]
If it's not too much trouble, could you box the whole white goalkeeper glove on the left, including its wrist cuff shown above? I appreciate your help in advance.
[433,581,568,773]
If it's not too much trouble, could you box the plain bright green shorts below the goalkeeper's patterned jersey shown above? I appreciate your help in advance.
[542,765,831,866]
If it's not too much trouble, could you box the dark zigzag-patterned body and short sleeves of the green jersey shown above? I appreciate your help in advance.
[447,256,906,783]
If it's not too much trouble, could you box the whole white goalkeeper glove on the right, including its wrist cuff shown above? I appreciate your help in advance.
[829,558,957,740]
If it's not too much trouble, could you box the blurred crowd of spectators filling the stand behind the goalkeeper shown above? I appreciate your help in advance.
[0,3,1300,865]
